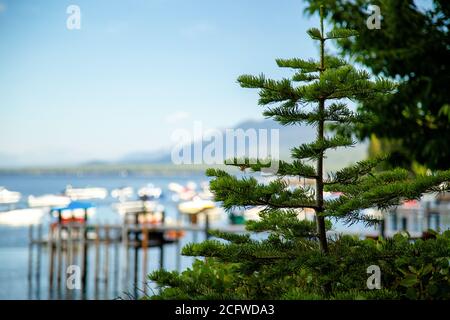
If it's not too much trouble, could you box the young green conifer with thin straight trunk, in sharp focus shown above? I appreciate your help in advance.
[150,7,450,299]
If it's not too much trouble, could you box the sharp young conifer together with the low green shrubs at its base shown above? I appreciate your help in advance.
[150,8,450,299]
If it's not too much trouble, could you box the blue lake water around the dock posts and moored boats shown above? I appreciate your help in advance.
[0,174,450,299]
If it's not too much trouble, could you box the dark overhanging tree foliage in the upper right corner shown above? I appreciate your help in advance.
[306,0,450,172]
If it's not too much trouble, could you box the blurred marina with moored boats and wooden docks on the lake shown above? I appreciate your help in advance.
[0,175,450,299]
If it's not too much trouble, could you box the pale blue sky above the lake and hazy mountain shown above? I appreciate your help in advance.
[0,0,324,165]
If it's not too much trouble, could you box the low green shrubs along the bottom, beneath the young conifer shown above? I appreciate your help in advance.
[150,231,450,300]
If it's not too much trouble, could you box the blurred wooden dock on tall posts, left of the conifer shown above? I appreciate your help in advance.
[28,210,245,299]
